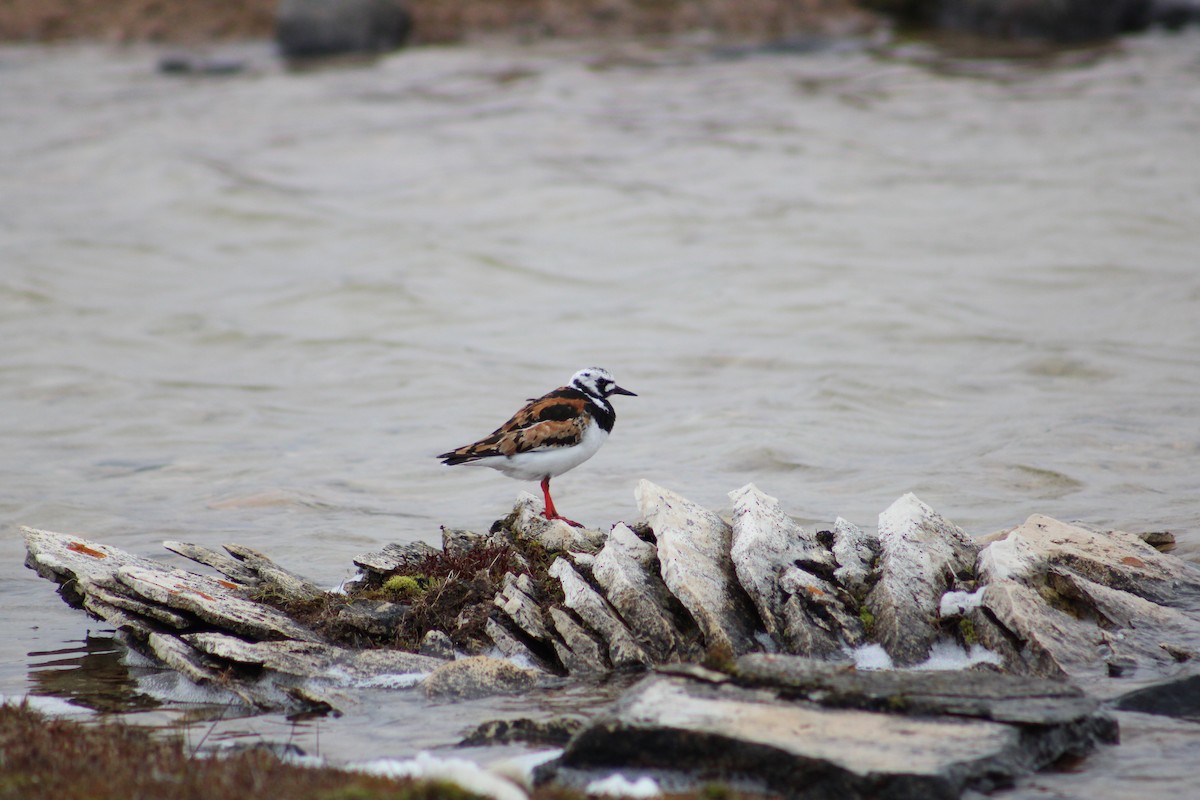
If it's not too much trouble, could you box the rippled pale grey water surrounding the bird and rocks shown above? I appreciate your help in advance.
[0,26,1200,786]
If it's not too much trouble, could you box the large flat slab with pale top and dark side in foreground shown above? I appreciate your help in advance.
[549,672,1115,800]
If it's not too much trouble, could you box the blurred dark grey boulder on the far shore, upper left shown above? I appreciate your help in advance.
[275,0,413,58]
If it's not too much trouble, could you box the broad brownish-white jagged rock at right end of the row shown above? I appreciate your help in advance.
[966,515,1200,676]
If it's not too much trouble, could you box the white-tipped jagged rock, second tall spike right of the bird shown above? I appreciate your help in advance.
[730,483,860,655]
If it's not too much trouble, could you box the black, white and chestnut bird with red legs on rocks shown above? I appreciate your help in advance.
[438,367,637,528]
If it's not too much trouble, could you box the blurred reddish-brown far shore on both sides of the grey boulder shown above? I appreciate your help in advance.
[0,0,871,43]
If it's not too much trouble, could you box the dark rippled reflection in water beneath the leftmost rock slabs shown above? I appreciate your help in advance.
[29,633,160,712]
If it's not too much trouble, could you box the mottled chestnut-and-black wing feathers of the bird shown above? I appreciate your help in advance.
[438,387,592,464]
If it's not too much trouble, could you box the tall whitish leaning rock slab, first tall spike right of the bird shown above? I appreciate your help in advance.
[635,481,758,655]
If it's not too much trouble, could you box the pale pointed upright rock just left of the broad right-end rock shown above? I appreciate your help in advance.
[866,493,978,666]
